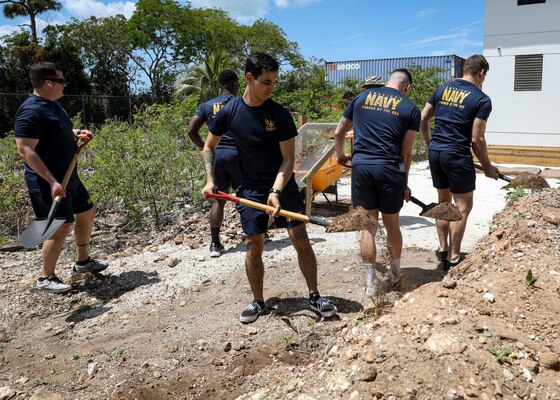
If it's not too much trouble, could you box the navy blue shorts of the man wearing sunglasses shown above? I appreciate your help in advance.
[29,182,93,223]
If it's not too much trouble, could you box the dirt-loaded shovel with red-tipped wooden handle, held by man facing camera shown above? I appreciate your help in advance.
[204,192,376,232]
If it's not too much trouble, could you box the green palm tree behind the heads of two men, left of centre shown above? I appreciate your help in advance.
[173,51,235,102]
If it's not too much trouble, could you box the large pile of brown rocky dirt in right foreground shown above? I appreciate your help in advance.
[240,190,560,399]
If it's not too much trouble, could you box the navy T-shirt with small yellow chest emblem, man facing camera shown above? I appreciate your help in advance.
[209,97,297,189]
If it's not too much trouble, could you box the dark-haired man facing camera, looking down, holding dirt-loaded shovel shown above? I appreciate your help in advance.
[202,53,337,323]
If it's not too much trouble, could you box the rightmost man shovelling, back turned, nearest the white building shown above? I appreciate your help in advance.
[420,55,498,271]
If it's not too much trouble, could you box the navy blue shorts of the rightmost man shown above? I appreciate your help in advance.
[428,150,476,194]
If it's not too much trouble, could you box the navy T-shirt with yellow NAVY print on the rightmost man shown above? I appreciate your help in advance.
[428,79,492,154]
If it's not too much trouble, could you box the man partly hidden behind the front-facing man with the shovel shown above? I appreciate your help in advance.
[188,69,241,257]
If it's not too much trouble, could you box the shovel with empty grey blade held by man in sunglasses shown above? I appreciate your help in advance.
[19,136,93,249]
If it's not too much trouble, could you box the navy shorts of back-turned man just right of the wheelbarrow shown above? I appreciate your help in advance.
[352,163,406,214]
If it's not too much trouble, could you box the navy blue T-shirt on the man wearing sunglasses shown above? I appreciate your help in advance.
[14,94,79,193]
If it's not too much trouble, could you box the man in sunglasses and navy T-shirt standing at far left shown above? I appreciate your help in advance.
[14,62,108,293]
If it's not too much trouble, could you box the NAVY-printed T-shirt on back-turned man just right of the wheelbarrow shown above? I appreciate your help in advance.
[343,87,420,165]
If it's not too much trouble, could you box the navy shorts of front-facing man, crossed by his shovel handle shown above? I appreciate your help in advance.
[237,179,304,235]
